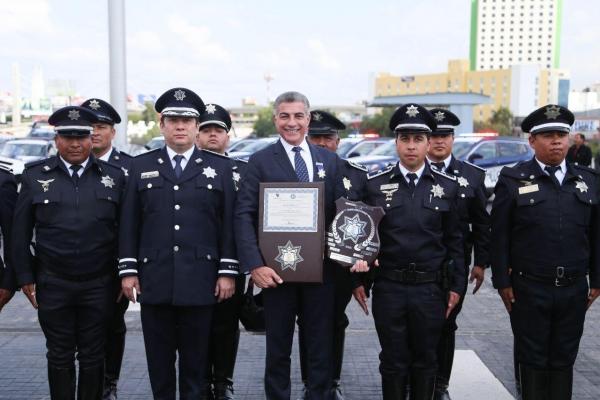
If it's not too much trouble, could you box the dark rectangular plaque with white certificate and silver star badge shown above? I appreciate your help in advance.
[258,182,325,283]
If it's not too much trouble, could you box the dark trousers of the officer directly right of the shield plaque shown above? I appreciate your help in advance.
[373,278,445,380]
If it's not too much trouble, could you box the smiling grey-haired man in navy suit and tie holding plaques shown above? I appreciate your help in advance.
[235,92,356,400]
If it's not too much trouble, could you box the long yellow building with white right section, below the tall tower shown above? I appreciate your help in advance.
[374,60,569,121]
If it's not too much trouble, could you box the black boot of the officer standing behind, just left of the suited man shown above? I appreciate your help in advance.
[213,331,240,400]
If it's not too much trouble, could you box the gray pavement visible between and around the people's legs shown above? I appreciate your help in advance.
[0,281,600,400]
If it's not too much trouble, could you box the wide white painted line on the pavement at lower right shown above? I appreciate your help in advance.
[450,350,514,400]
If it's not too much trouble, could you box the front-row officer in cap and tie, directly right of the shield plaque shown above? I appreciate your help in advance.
[356,104,467,400]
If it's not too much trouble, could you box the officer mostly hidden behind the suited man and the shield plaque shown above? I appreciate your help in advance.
[298,110,367,400]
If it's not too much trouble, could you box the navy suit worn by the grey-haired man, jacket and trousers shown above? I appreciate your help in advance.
[235,130,344,399]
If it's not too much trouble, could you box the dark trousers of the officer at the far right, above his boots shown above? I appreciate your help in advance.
[510,274,588,370]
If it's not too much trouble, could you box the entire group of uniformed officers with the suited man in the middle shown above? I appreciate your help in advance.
[0,88,600,400]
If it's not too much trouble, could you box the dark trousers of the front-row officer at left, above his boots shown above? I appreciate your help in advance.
[36,271,114,369]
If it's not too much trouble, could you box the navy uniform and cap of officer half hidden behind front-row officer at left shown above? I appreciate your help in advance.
[81,98,132,400]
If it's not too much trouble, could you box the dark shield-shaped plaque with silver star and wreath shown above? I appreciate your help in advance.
[327,197,385,267]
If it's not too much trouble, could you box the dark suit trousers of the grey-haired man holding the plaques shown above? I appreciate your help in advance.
[263,283,335,400]
